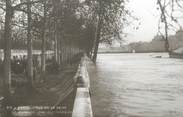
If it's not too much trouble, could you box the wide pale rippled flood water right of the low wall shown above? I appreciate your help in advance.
[89,53,183,117]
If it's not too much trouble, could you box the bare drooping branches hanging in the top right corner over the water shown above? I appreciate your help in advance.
[157,0,183,53]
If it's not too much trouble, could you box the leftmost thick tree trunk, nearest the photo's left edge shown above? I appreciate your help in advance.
[3,0,13,97]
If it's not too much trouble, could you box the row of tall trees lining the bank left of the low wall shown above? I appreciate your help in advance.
[0,0,129,109]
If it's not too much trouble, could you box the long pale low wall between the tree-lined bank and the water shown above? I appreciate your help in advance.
[72,56,93,117]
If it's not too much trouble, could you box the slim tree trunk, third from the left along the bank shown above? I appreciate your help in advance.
[41,2,46,80]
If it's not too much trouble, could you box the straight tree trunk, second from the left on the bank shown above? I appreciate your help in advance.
[27,0,33,87]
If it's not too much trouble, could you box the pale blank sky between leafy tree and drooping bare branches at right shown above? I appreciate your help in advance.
[126,0,159,42]
